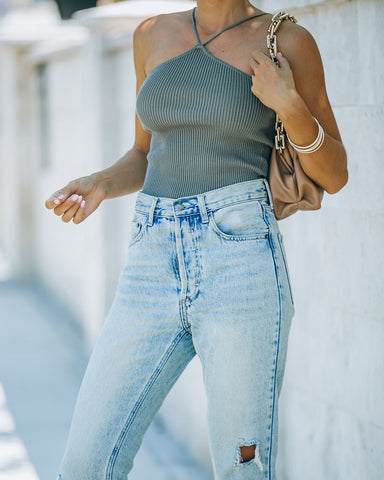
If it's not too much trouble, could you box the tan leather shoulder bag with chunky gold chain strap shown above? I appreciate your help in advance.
[267,12,324,220]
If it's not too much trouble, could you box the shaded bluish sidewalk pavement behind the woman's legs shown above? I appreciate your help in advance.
[0,281,209,480]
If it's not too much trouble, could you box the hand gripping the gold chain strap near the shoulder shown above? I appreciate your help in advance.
[249,50,295,112]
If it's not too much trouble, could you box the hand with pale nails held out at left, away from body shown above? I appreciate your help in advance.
[45,174,107,224]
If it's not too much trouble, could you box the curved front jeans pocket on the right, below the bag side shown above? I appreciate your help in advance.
[209,199,269,240]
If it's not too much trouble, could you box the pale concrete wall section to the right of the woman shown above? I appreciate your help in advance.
[255,0,384,480]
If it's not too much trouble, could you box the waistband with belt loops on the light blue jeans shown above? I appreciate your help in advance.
[135,178,273,225]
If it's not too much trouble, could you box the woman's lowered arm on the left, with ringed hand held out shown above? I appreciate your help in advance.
[45,19,151,224]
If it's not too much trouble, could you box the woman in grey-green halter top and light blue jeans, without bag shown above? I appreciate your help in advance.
[46,0,348,480]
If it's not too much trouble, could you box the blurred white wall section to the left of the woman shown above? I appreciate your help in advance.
[0,1,195,348]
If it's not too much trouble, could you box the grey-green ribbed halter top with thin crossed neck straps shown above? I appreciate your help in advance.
[136,7,276,198]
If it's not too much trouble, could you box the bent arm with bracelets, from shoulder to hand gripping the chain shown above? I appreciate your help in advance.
[250,21,348,194]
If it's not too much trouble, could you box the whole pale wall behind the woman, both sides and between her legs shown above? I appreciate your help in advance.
[0,0,384,480]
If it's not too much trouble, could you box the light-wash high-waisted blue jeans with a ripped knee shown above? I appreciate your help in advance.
[58,179,294,480]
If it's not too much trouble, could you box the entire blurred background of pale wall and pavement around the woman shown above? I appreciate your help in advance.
[0,0,384,480]
